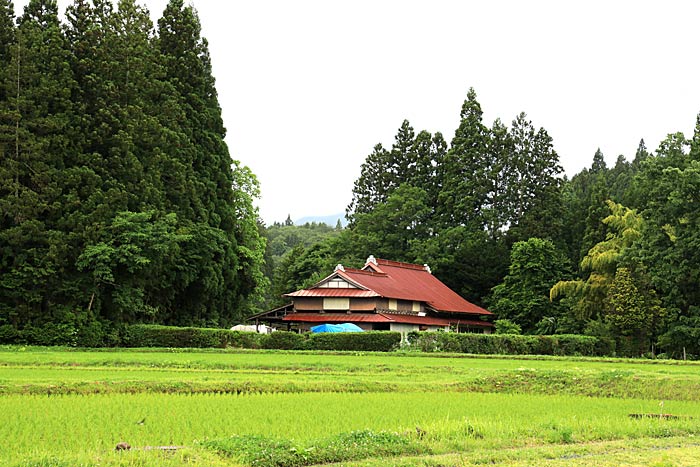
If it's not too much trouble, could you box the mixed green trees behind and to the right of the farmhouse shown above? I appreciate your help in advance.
[276,90,700,355]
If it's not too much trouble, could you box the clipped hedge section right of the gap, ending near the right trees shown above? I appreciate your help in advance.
[408,332,615,356]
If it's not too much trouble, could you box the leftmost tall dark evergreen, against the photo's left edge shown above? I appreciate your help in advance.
[0,0,75,326]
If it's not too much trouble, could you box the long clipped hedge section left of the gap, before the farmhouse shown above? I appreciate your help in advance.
[124,324,401,352]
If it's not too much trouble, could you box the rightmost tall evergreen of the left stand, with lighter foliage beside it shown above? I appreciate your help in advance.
[158,0,265,323]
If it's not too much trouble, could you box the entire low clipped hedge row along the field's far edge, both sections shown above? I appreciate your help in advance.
[0,323,615,356]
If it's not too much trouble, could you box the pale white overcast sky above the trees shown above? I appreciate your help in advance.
[16,0,700,224]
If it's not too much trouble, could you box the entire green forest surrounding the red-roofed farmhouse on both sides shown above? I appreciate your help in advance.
[0,0,700,356]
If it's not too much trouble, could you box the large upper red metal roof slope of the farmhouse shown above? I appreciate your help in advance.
[336,259,492,315]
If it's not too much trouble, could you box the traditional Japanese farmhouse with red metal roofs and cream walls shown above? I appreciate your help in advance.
[251,256,493,333]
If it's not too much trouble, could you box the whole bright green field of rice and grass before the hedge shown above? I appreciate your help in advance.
[0,347,700,467]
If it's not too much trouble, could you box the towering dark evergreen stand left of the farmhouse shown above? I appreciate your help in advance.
[0,0,266,341]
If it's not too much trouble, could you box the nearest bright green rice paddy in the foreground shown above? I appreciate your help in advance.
[5,392,700,465]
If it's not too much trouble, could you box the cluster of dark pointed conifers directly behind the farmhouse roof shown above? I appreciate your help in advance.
[268,90,562,304]
